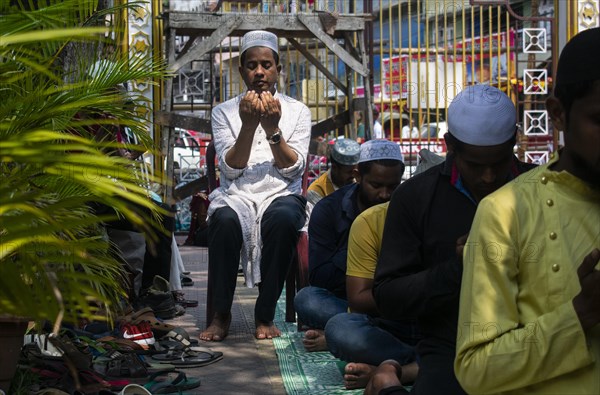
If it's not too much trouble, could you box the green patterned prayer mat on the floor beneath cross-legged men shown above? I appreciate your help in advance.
[273,290,363,395]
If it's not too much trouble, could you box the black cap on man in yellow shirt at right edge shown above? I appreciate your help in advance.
[555,27,600,86]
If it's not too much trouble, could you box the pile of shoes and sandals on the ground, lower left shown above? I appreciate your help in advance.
[19,316,223,395]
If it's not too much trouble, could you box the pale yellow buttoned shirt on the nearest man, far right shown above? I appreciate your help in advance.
[454,154,600,395]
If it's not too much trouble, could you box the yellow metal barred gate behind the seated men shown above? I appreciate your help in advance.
[134,0,600,189]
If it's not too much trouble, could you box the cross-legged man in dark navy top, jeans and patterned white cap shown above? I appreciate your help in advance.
[294,140,404,351]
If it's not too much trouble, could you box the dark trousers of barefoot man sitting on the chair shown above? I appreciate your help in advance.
[208,195,306,322]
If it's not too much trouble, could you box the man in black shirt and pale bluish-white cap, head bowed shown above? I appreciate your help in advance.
[367,85,534,395]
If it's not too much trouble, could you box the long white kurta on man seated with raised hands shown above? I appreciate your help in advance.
[208,93,311,287]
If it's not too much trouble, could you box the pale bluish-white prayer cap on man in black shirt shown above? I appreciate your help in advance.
[448,85,517,146]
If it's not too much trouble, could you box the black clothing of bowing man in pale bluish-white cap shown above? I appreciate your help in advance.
[373,155,534,395]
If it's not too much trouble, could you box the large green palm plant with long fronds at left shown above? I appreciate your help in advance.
[0,0,164,390]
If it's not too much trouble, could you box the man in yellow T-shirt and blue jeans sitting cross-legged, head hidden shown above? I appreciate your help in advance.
[325,202,420,389]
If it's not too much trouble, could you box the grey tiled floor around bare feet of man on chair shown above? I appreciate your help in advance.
[164,236,286,395]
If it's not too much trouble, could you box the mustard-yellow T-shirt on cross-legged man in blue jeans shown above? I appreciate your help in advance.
[346,202,390,280]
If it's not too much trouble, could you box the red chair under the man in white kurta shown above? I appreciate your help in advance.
[206,142,308,328]
